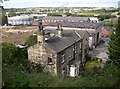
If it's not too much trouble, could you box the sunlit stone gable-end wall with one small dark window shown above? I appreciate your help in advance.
[28,44,57,75]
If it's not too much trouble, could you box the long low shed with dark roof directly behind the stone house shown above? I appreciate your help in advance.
[44,22,102,48]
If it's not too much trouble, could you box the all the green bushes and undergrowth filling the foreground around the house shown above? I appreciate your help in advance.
[2,44,120,89]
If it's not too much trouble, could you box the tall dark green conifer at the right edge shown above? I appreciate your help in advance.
[108,18,120,64]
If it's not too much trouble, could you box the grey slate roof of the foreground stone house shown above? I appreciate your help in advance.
[45,31,82,53]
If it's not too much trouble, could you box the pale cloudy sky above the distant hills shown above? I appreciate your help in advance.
[0,0,120,8]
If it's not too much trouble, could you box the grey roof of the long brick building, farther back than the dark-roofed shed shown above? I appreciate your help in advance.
[42,16,89,21]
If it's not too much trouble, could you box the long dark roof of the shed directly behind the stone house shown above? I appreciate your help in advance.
[44,22,101,29]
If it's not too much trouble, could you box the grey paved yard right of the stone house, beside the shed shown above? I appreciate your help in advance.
[89,38,109,63]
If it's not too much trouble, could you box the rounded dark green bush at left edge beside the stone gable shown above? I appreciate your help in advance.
[2,43,28,65]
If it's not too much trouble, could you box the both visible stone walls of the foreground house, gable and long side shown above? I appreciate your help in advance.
[28,38,86,76]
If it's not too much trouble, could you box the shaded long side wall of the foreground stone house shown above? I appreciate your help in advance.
[57,40,82,76]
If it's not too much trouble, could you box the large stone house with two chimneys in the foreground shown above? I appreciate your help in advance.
[28,25,89,77]
